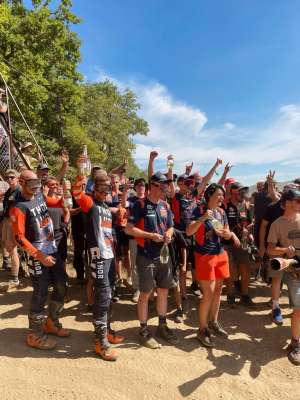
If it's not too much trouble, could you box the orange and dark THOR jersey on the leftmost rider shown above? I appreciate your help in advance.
[9,193,61,259]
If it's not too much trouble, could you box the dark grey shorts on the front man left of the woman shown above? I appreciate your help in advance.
[136,253,177,293]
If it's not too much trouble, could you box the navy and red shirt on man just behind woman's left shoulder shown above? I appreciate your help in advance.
[171,193,196,232]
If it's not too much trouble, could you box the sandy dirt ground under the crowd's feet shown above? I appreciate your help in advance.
[0,266,300,400]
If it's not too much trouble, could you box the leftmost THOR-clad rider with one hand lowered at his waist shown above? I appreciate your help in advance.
[9,170,70,350]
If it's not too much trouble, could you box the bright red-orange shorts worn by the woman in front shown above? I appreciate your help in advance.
[195,251,230,281]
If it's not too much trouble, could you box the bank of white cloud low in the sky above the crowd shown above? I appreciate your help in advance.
[94,71,300,178]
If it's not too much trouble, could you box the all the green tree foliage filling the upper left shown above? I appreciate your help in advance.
[0,0,148,175]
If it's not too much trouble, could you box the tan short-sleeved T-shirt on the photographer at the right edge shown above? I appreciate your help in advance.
[268,214,300,256]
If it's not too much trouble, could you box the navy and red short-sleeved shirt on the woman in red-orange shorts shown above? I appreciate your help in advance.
[192,206,228,255]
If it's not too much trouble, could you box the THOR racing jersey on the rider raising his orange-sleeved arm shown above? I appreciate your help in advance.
[73,185,114,260]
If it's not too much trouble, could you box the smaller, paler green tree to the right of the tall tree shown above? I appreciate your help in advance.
[79,80,148,170]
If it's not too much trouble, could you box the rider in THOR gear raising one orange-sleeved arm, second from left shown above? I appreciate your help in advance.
[73,166,124,361]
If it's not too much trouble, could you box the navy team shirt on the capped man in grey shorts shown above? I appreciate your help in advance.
[128,199,173,260]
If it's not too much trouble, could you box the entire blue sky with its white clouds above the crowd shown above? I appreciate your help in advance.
[73,0,300,183]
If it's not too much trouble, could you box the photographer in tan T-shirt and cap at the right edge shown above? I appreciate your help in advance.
[268,189,300,365]
